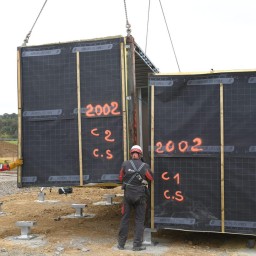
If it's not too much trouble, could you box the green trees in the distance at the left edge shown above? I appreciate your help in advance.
[0,113,18,139]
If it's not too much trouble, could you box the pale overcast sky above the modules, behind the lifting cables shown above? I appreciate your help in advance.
[0,0,256,114]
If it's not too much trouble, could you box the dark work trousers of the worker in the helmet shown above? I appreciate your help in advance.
[118,186,146,247]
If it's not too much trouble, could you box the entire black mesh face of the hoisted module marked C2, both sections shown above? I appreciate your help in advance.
[20,38,123,186]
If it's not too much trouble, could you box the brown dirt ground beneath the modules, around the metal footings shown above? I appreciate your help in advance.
[0,141,256,256]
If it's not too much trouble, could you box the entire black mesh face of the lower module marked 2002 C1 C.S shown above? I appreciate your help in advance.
[149,72,256,234]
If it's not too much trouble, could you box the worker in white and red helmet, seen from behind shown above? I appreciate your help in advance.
[117,145,153,251]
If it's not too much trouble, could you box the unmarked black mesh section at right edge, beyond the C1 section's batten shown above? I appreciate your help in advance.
[224,72,256,234]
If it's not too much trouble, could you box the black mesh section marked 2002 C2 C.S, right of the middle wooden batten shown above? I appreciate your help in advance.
[80,40,123,182]
